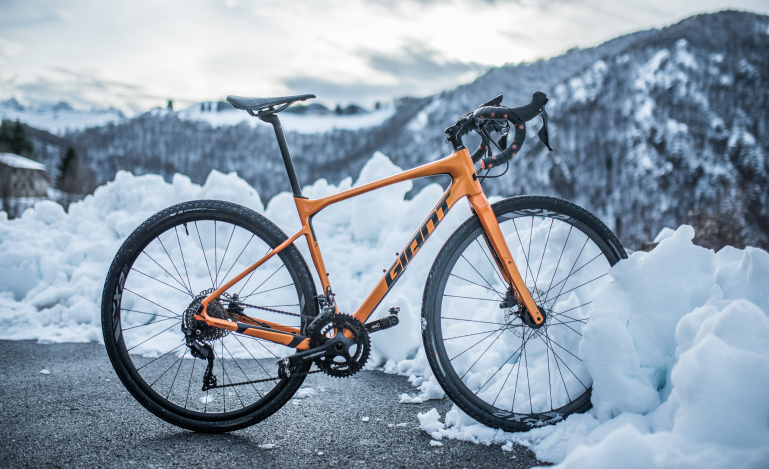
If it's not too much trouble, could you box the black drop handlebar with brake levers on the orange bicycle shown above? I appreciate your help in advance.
[446,91,553,169]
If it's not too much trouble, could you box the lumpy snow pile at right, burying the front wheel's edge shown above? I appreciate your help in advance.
[420,226,769,468]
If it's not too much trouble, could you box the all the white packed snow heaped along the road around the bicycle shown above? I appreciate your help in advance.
[0,153,769,467]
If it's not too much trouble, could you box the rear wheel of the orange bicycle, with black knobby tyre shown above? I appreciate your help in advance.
[102,200,318,432]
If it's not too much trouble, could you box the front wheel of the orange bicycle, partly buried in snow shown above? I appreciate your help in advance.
[422,196,627,431]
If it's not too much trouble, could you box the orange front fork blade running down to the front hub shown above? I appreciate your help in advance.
[468,192,545,325]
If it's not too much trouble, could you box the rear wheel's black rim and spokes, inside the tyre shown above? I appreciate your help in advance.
[117,213,302,421]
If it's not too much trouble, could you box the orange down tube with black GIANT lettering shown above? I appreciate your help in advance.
[354,184,456,323]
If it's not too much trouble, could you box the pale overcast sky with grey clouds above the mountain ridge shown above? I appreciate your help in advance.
[0,0,769,115]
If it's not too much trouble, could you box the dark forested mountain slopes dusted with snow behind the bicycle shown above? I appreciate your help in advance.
[27,11,769,248]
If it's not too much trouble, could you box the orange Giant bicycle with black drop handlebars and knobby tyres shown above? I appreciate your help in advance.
[102,92,627,432]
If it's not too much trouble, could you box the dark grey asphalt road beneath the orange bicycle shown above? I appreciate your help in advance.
[0,341,541,468]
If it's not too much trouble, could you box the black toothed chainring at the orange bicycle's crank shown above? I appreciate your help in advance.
[309,314,371,378]
